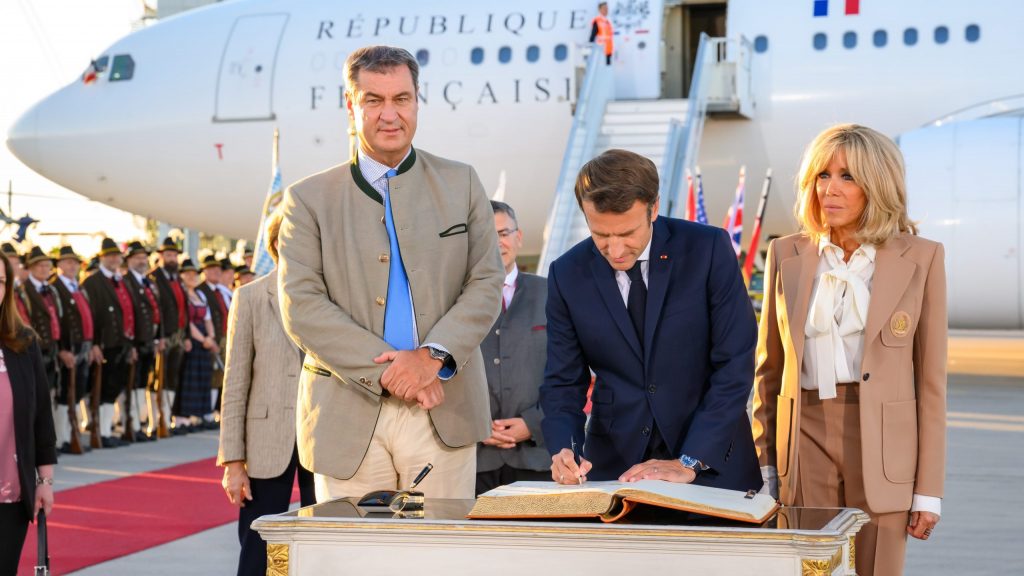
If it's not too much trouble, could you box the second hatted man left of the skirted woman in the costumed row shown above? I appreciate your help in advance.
[124,241,161,442]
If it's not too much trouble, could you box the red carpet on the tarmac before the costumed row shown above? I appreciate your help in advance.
[18,458,298,576]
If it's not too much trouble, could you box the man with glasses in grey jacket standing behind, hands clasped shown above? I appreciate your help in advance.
[476,200,551,494]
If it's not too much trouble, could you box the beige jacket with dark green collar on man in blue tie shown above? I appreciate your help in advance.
[279,145,505,480]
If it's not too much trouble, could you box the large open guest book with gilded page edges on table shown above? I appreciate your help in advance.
[467,480,778,524]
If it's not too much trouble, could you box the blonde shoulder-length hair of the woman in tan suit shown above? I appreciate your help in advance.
[794,124,918,246]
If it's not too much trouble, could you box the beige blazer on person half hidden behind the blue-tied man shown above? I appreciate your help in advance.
[217,271,302,479]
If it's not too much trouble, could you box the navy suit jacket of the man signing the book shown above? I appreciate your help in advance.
[541,217,762,490]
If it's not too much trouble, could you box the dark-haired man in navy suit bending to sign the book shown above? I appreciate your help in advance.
[541,150,762,490]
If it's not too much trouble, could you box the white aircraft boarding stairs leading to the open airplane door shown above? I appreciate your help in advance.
[538,34,754,275]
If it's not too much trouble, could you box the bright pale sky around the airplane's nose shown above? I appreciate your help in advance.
[0,0,144,255]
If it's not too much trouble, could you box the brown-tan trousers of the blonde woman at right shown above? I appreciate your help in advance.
[794,384,909,576]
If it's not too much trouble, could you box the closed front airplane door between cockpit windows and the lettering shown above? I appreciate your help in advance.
[213,14,288,122]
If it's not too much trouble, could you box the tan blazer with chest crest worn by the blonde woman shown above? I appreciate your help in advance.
[753,234,947,513]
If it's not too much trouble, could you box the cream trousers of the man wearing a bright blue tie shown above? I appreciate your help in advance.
[313,398,476,502]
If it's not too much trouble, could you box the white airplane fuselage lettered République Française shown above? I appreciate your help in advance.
[8,0,1024,325]
